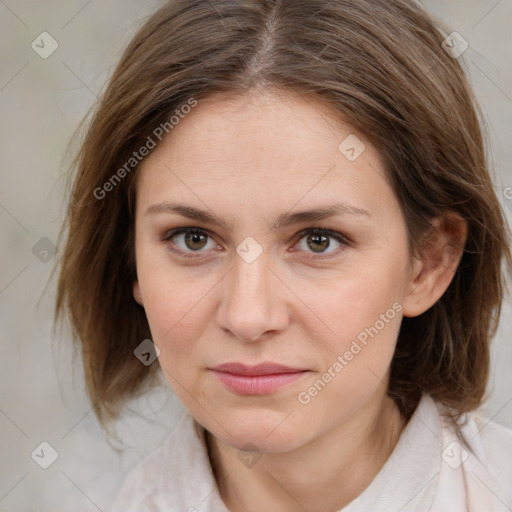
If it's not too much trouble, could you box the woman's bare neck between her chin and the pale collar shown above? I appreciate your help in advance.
[205,394,406,512]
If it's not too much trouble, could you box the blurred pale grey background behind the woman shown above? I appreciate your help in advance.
[0,0,512,512]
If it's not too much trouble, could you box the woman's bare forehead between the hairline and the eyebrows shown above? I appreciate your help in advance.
[137,88,390,222]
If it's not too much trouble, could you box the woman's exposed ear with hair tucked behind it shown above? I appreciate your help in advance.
[403,211,468,317]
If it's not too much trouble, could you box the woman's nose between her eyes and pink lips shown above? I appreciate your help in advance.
[217,252,289,342]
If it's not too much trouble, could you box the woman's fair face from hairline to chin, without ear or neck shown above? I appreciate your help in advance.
[134,88,420,452]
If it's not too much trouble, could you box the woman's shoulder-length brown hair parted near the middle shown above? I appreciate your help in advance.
[55,0,512,426]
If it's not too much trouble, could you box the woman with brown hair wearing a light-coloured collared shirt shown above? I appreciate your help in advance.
[56,0,512,512]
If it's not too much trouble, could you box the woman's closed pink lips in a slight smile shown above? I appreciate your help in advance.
[210,363,308,395]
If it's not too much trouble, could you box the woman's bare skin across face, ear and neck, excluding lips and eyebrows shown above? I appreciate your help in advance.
[133,90,467,512]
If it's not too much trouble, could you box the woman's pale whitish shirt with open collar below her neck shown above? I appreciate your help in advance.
[111,395,512,512]
